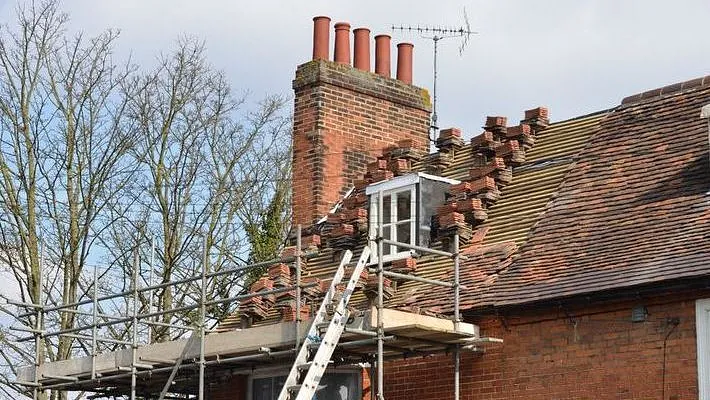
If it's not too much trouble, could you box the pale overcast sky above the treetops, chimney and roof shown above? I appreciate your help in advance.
[0,0,710,137]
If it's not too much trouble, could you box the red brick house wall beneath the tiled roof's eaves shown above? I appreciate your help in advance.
[385,296,710,400]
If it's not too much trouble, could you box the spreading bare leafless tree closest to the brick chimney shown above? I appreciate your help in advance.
[101,39,290,341]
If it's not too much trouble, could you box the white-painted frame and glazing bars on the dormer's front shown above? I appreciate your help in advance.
[369,183,418,263]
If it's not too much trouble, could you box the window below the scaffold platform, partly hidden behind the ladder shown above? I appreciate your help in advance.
[251,370,362,400]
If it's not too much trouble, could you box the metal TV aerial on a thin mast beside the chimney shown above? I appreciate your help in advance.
[392,8,478,142]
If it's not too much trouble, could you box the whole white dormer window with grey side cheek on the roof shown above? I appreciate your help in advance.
[365,173,459,262]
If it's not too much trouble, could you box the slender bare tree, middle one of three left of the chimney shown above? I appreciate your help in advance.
[40,20,135,368]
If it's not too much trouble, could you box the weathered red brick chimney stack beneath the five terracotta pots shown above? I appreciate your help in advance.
[293,60,430,226]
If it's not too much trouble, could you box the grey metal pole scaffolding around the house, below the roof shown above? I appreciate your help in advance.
[8,223,497,400]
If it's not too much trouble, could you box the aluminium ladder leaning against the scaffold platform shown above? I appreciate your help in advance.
[278,247,370,400]
